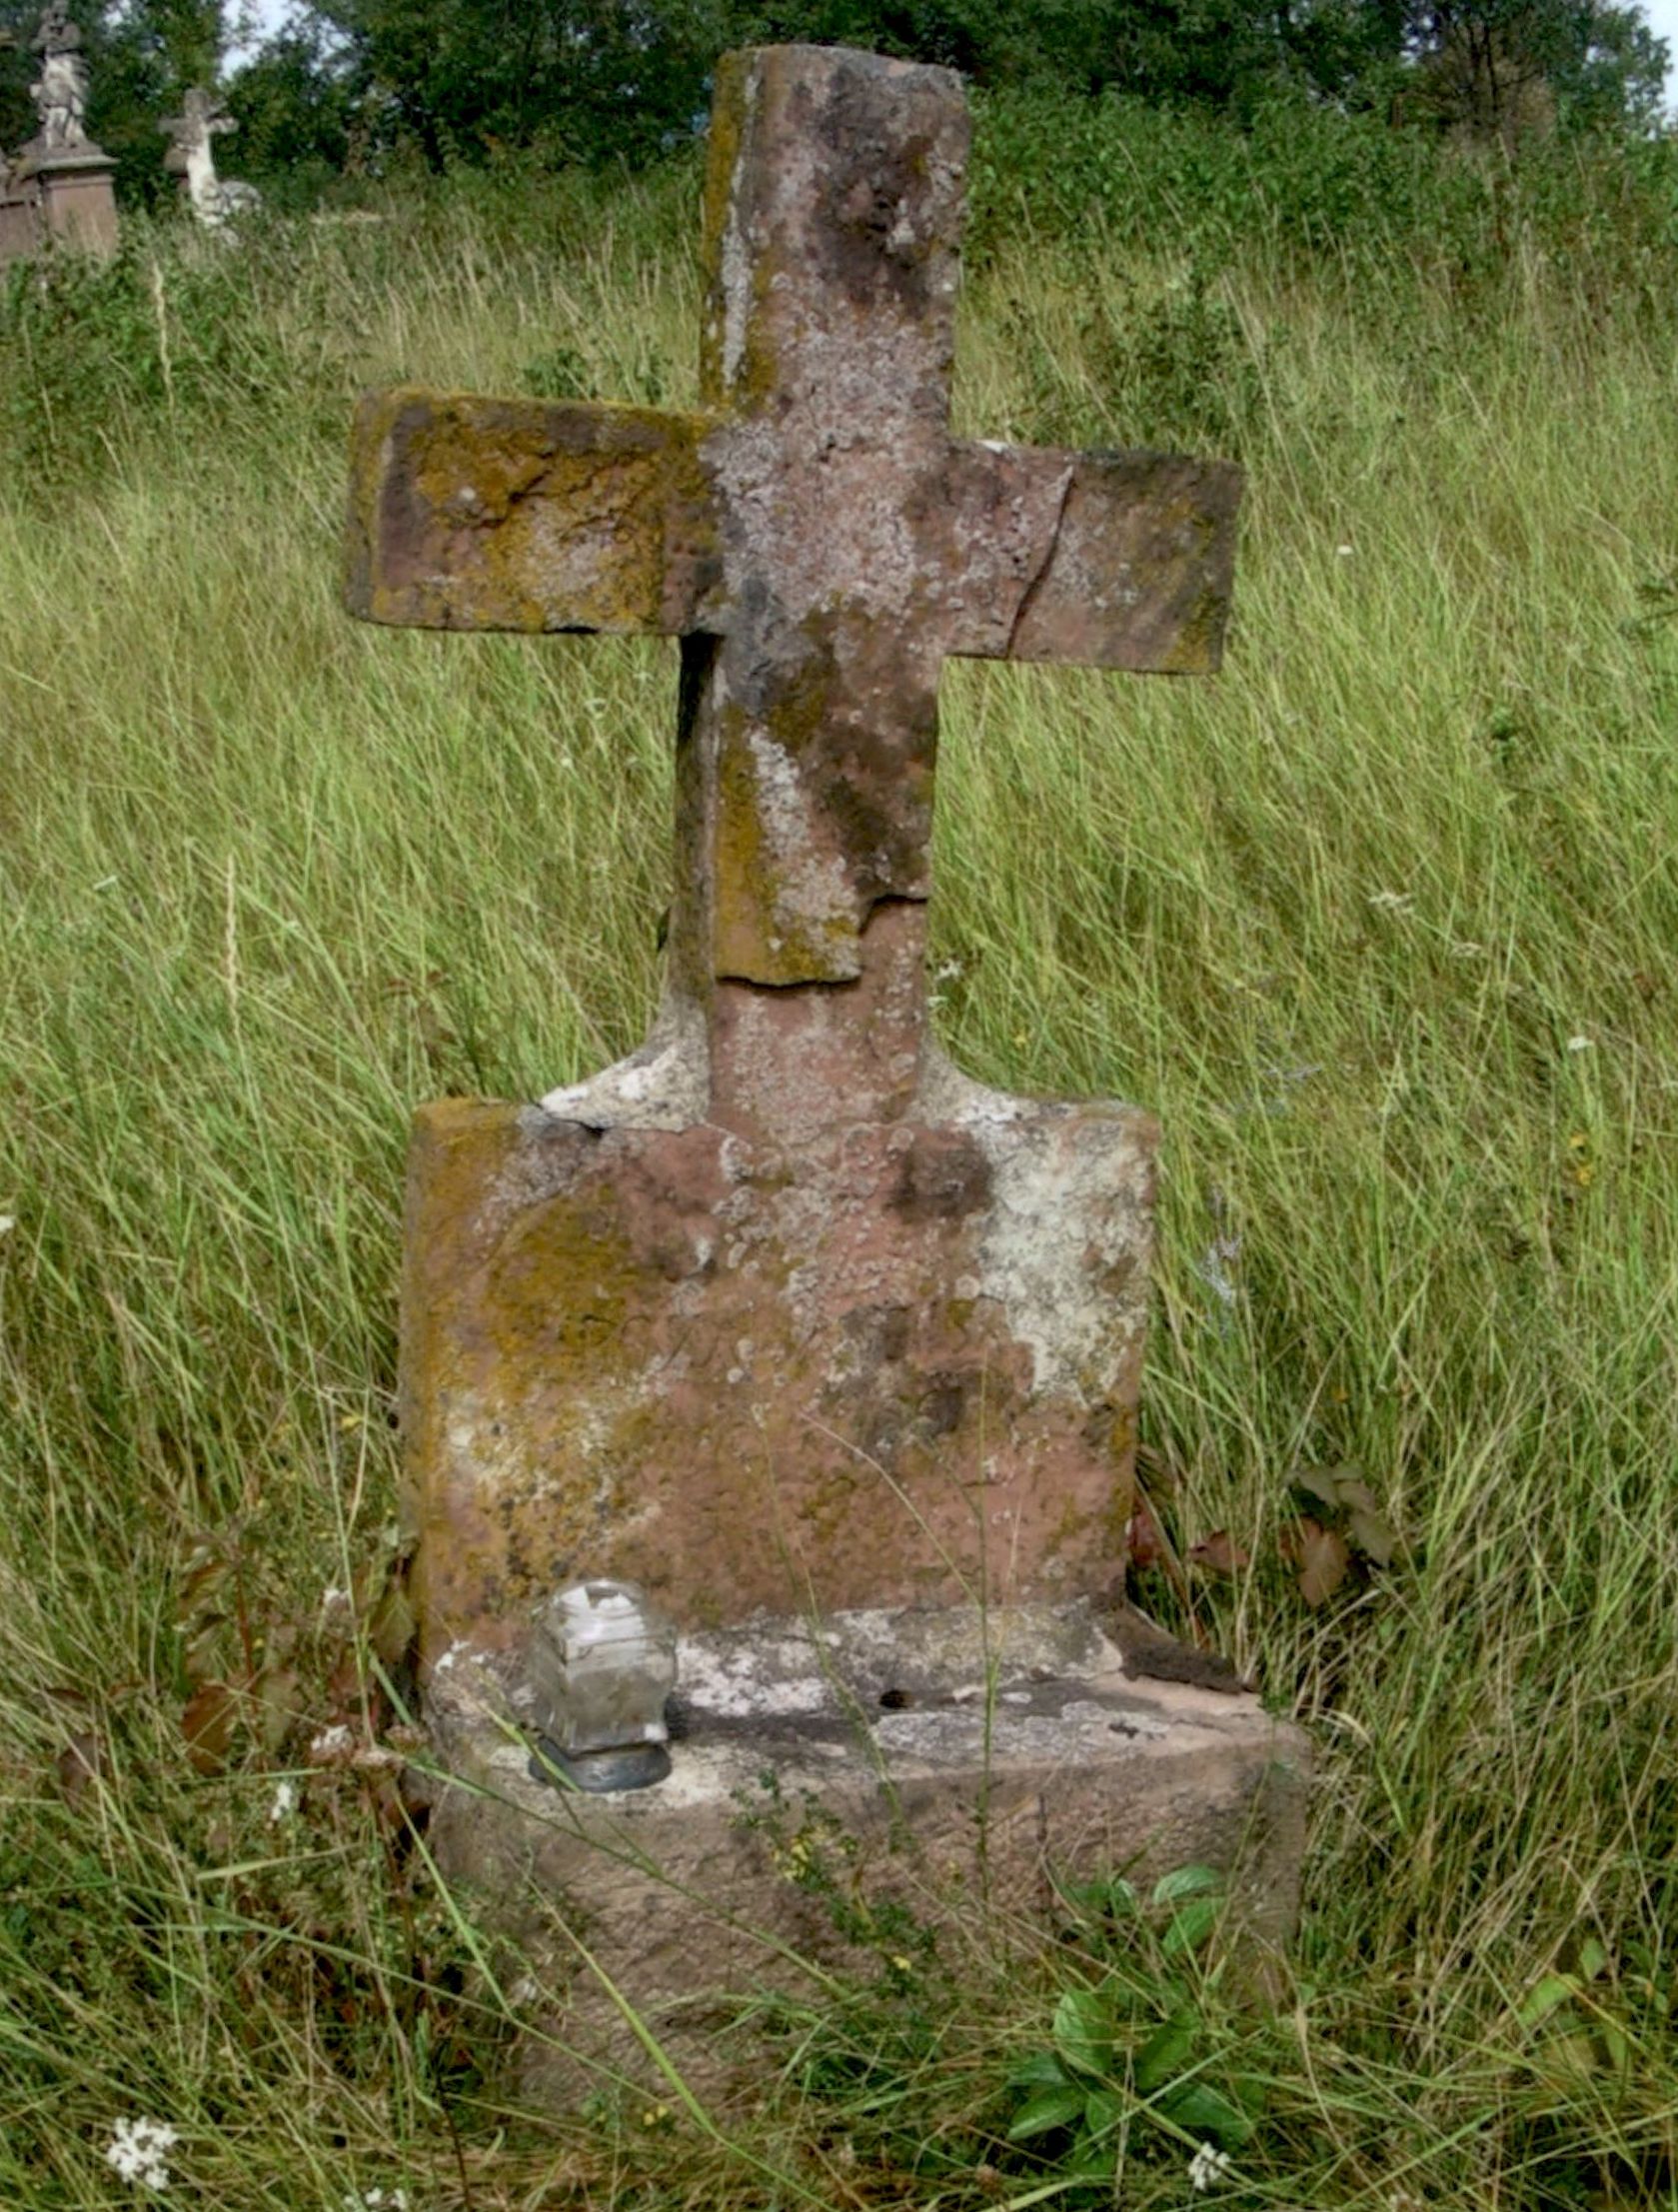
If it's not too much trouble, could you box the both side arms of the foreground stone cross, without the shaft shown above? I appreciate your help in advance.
[347,389,1240,675]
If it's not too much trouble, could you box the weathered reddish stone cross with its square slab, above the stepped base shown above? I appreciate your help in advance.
[347,46,1240,1659]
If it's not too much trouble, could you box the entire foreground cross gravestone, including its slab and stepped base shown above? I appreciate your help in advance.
[347,46,1306,2092]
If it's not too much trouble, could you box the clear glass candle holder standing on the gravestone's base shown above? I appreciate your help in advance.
[531,1581,677,1789]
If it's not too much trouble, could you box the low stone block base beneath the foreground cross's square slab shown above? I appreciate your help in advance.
[427,1601,1309,2108]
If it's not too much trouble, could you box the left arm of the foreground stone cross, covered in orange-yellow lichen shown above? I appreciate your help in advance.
[345,387,721,635]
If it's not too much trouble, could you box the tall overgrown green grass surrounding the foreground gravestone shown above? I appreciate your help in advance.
[0,107,1678,2212]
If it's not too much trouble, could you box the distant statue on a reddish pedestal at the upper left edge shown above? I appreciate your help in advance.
[0,0,117,263]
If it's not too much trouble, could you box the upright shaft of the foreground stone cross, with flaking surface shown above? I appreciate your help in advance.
[675,49,968,1136]
